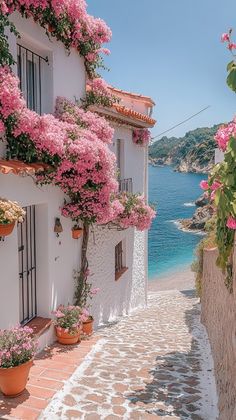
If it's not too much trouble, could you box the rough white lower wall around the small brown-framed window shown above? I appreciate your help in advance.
[88,227,147,325]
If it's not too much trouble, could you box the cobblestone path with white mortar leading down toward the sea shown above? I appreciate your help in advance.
[41,291,217,420]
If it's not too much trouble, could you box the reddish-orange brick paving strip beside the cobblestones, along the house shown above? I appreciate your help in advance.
[0,337,98,420]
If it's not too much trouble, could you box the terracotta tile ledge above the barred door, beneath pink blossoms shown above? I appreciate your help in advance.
[0,159,49,175]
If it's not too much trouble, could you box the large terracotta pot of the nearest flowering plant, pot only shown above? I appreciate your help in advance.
[0,359,33,397]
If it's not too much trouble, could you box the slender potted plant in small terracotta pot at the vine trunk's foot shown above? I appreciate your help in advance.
[74,269,99,335]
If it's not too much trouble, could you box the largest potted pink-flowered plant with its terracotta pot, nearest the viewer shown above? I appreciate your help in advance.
[0,327,37,397]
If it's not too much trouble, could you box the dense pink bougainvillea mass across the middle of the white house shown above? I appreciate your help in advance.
[0,68,118,222]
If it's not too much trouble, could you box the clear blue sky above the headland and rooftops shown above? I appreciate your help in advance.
[87,0,236,136]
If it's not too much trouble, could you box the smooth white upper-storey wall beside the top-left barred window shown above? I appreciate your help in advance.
[9,13,86,113]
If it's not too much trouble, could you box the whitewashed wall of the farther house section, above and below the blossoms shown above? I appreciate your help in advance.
[88,121,147,325]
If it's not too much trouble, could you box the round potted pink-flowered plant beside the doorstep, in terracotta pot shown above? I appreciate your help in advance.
[54,305,82,344]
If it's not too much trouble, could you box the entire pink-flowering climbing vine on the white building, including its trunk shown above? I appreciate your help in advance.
[0,0,155,302]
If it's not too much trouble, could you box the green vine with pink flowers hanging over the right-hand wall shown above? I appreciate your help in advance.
[201,29,236,292]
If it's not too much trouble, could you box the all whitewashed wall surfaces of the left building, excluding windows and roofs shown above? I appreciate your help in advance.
[0,14,147,334]
